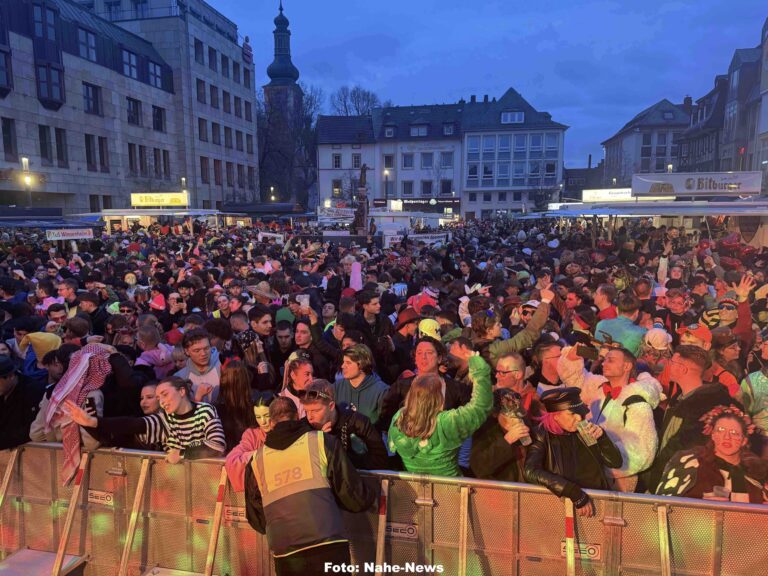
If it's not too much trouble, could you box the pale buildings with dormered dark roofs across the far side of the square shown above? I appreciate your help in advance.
[318,89,567,219]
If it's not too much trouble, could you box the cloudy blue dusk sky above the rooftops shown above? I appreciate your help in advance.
[213,0,768,167]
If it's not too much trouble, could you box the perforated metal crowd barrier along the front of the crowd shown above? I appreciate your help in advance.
[0,444,768,576]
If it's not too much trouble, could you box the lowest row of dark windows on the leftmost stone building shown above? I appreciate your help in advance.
[2,118,171,180]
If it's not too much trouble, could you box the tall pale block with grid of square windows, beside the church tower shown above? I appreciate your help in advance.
[78,0,259,208]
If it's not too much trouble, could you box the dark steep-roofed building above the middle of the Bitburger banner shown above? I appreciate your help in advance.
[678,75,728,172]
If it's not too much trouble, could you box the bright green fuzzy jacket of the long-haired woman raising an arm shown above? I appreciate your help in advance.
[389,356,493,476]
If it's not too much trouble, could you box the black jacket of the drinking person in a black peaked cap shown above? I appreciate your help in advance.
[525,424,622,505]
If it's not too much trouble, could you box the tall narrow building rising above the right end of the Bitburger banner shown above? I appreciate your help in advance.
[720,47,762,171]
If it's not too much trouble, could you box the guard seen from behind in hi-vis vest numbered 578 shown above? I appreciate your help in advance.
[245,398,376,576]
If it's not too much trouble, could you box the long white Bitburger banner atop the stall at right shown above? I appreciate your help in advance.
[632,172,763,196]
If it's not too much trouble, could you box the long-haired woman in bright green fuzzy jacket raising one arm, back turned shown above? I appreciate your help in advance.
[389,350,492,476]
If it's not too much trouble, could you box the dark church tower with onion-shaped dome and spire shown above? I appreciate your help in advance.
[260,0,304,204]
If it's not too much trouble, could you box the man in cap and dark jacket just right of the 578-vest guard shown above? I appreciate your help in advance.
[301,379,389,470]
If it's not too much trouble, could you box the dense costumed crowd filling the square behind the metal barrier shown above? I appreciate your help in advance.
[0,214,768,554]
